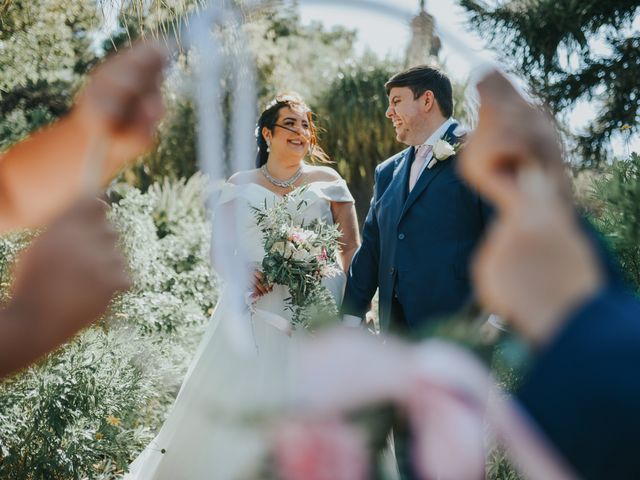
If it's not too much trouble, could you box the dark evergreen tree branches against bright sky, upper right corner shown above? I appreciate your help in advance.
[460,0,640,166]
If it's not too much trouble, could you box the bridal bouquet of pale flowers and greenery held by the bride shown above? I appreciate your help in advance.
[254,191,341,328]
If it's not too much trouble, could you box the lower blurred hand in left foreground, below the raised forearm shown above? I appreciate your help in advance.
[0,199,130,376]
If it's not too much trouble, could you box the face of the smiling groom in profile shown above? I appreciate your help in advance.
[385,87,426,145]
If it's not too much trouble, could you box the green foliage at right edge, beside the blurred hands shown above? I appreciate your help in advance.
[594,153,640,292]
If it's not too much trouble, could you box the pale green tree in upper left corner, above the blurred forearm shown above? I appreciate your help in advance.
[0,0,99,150]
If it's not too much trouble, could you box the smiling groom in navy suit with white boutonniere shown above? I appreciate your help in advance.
[342,66,489,334]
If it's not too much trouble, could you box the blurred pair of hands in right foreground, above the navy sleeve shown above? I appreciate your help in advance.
[461,73,603,345]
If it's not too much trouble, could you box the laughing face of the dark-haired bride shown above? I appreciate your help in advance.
[263,107,311,162]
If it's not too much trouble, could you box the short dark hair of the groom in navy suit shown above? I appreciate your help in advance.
[384,65,453,118]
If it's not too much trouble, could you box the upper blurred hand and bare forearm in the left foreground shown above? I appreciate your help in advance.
[0,42,167,232]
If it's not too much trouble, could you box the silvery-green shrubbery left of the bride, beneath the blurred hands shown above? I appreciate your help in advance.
[0,176,217,480]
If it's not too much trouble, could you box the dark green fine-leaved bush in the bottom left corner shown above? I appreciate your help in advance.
[0,328,153,479]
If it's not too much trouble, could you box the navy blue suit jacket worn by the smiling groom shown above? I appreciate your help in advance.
[342,123,489,331]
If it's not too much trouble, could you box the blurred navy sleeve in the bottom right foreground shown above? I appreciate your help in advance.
[518,287,640,479]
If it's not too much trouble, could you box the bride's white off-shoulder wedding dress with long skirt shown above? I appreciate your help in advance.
[125,180,353,480]
